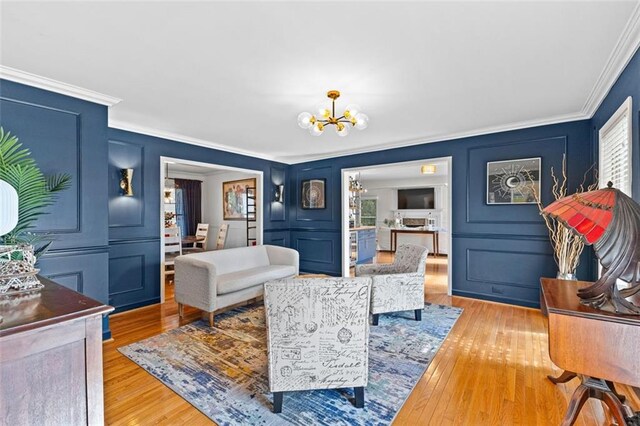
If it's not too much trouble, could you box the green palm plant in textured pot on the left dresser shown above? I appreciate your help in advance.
[0,126,71,293]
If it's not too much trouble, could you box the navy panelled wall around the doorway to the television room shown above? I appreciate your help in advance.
[289,120,592,306]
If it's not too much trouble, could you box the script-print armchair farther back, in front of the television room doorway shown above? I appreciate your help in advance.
[356,244,429,325]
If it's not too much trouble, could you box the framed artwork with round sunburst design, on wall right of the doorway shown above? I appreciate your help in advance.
[487,157,541,205]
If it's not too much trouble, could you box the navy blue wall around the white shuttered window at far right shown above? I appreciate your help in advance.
[591,50,640,201]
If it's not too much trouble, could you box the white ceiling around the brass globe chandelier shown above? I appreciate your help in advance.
[0,1,640,163]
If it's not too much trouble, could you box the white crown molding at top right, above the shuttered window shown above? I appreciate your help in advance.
[582,2,640,118]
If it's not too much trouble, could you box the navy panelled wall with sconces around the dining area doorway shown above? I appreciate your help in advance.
[107,129,289,311]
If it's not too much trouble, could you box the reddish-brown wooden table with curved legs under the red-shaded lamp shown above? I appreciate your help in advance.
[540,278,640,426]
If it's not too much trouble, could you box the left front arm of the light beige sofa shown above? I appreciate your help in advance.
[174,255,217,312]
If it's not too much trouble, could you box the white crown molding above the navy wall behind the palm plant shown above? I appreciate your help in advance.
[0,65,121,107]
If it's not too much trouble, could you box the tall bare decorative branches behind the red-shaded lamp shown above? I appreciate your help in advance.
[529,155,598,279]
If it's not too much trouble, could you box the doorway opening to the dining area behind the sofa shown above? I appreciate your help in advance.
[159,157,264,303]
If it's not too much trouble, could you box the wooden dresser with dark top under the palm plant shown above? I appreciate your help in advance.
[0,277,113,425]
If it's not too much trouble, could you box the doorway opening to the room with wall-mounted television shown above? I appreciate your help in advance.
[342,157,453,296]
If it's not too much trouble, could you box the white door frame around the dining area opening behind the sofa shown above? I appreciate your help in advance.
[160,156,264,303]
